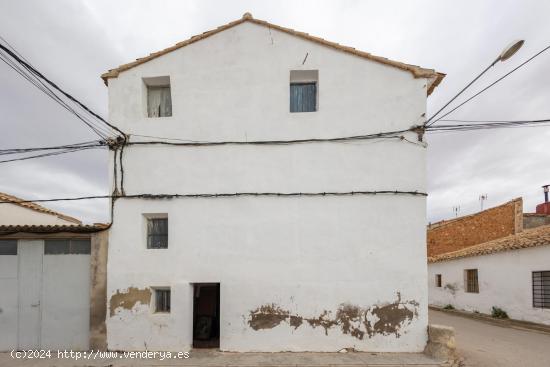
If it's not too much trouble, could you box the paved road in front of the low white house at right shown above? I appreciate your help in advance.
[430,310,550,367]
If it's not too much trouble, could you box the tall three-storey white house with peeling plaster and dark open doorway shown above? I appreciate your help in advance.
[103,13,444,352]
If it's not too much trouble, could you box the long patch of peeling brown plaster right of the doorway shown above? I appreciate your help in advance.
[248,292,419,340]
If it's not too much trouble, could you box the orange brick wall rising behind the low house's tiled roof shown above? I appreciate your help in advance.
[428,198,523,256]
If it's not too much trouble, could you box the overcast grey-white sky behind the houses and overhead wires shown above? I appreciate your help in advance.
[0,0,550,222]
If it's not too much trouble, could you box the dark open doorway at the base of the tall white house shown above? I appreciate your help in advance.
[193,283,220,348]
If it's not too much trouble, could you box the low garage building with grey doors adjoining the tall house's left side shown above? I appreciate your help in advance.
[0,193,107,351]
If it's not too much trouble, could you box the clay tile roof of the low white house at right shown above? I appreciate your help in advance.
[428,225,550,263]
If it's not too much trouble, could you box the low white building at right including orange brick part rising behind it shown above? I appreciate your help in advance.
[428,194,550,325]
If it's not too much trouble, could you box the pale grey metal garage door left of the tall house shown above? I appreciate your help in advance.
[0,239,90,351]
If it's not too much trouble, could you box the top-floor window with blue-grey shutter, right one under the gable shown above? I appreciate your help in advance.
[290,70,319,112]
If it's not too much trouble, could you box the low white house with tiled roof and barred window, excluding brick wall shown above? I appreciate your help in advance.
[428,225,550,325]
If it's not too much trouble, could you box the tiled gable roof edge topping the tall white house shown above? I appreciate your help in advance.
[101,13,445,95]
